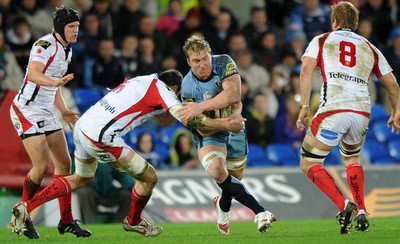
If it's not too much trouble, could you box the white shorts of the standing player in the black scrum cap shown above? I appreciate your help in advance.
[10,99,62,136]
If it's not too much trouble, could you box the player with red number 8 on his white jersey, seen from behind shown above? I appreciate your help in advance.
[297,1,400,234]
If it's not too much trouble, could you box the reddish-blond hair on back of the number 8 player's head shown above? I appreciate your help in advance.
[331,1,359,31]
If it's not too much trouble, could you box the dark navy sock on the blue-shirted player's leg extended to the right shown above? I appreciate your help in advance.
[218,175,265,214]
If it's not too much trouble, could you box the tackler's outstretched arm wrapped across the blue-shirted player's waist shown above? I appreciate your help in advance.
[168,104,246,133]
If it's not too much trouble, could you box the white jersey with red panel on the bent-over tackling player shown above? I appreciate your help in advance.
[78,74,180,143]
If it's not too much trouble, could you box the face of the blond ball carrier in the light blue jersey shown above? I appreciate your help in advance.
[187,49,212,80]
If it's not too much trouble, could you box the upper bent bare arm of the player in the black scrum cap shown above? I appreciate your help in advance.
[28,61,74,86]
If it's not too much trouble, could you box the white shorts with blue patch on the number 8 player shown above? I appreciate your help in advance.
[308,109,370,147]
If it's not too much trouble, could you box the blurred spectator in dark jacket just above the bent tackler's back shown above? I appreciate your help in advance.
[92,38,126,90]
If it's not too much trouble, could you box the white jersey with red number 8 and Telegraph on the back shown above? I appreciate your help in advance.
[302,29,392,113]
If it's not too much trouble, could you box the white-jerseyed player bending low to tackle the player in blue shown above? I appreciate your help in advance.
[11,70,245,236]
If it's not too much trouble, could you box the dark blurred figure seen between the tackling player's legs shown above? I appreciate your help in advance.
[75,163,134,224]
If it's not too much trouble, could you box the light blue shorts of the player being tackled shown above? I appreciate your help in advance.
[193,131,249,158]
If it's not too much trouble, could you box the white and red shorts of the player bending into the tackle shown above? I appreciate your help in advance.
[74,121,132,163]
